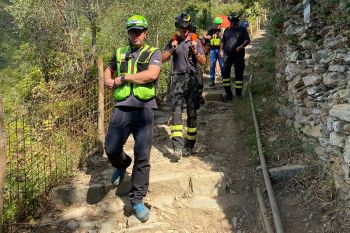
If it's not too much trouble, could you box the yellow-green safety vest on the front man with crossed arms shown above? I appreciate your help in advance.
[113,45,157,101]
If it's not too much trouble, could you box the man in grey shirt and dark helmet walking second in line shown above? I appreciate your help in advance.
[162,13,205,161]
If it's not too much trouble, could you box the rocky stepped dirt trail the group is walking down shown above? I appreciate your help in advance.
[30,33,263,233]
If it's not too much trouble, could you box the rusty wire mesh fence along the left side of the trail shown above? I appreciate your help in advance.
[3,80,109,232]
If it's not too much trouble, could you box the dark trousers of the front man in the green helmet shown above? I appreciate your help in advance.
[105,107,154,205]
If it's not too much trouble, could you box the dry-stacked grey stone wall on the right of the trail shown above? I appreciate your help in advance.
[276,3,350,197]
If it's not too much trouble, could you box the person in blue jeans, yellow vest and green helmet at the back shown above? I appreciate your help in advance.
[203,17,224,87]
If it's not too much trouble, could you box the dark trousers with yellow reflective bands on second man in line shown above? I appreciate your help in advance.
[170,73,199,149]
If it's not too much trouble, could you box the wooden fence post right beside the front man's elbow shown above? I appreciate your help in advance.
[97,58,105,156]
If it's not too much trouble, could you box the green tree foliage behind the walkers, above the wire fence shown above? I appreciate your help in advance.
[0,0,269,115]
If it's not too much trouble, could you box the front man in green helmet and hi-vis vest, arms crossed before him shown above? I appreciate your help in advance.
[104,15,162,222]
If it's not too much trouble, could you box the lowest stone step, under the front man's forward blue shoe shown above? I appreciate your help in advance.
[39,190,239,232]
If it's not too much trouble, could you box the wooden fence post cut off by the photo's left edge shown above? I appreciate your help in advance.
[0,98,7,233]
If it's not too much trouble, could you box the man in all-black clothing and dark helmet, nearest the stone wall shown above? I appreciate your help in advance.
[220,13,250,100]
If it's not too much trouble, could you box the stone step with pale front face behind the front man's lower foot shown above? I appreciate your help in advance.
[52,161,226,205]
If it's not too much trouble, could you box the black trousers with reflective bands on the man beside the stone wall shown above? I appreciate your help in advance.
[222,51,245,96]
